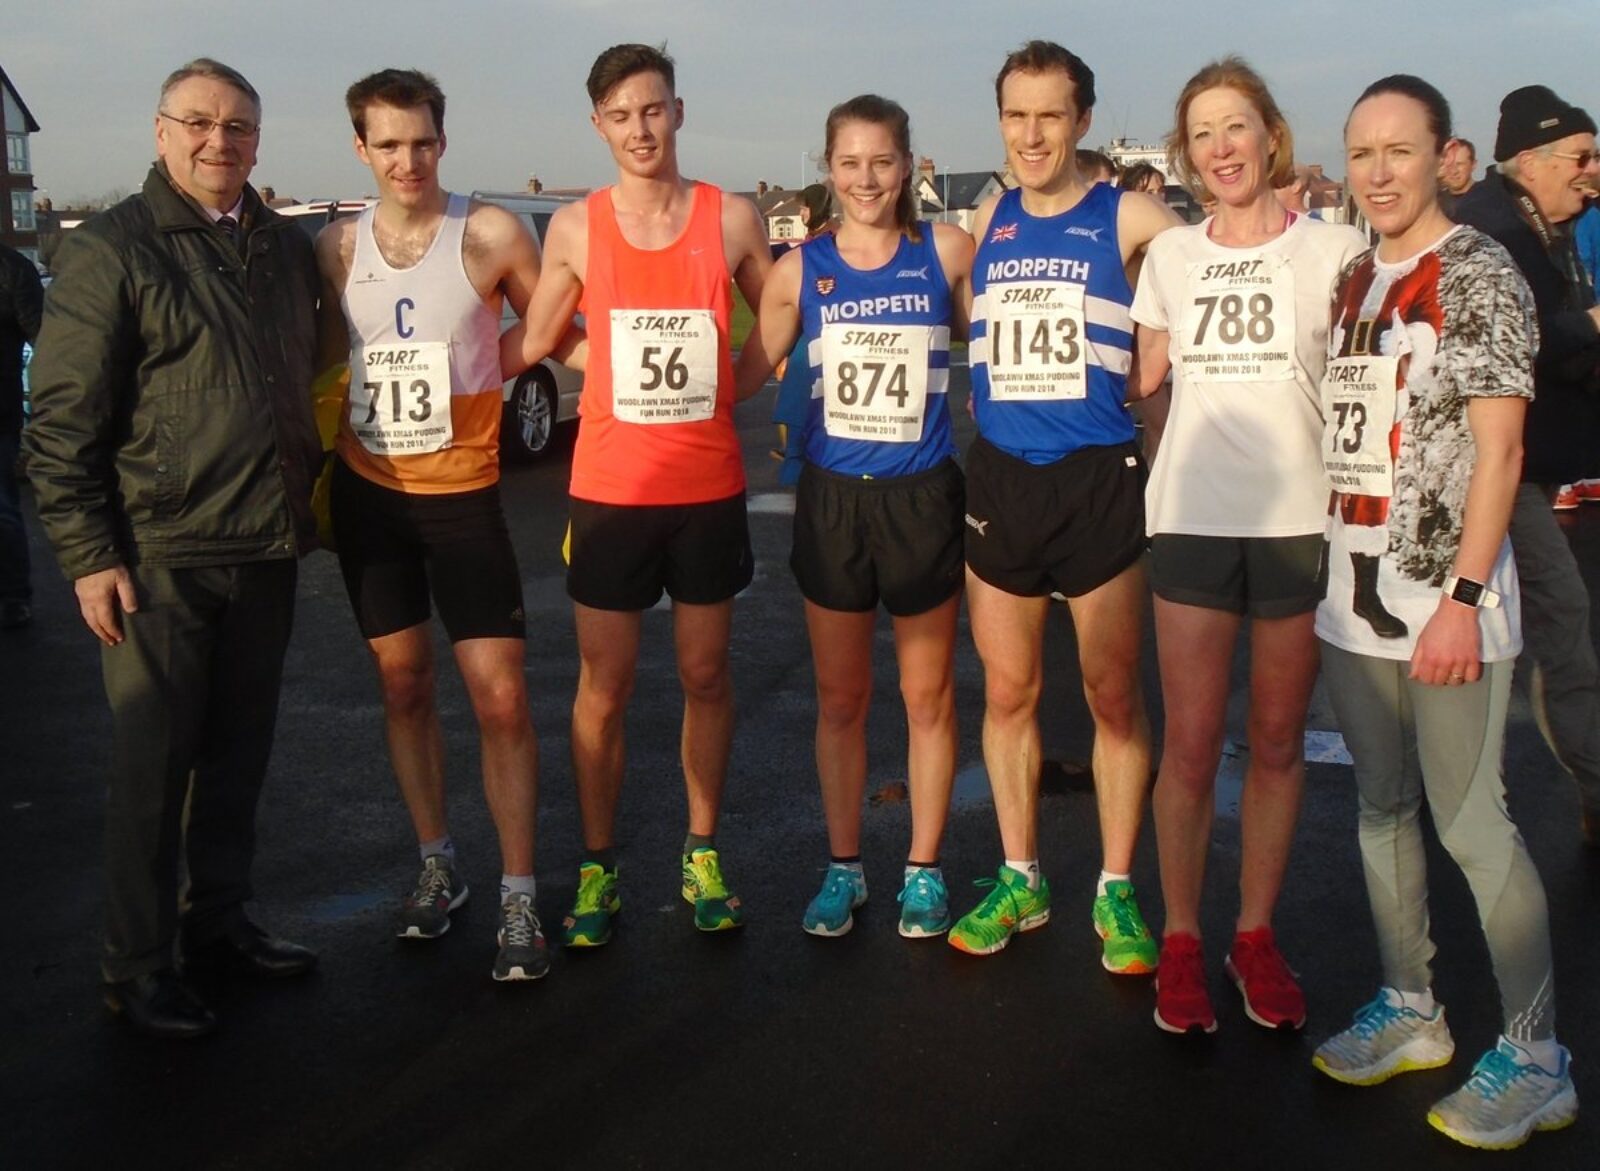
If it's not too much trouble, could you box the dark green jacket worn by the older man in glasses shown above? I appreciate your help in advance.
[26,165,322,579]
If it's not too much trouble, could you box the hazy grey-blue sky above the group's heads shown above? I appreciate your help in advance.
[12,0,1600,205]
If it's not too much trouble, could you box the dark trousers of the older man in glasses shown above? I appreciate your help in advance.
[101,560,296,981]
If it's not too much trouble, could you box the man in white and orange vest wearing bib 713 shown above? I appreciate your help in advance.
[317,69,549,981]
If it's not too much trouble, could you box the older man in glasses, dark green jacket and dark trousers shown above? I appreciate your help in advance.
[27,58,322,1037]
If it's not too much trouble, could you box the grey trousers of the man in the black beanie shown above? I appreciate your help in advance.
[1510,483,1600,813]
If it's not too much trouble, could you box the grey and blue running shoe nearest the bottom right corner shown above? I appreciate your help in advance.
[1427,1037,1578,1150]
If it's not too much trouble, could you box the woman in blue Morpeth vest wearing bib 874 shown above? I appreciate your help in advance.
[738,94,973,937]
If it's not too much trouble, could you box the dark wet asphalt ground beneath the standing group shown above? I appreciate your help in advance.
[9,378,1600,1168]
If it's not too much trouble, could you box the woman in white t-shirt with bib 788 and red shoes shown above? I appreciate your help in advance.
[1133,58,1365,1033]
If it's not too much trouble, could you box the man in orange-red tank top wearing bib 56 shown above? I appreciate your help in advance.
[501,45,771,947]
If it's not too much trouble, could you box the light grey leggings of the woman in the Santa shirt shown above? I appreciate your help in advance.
[1322,643,1555,1040]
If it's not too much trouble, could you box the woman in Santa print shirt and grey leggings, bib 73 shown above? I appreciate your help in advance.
[1314,75,1578,1147]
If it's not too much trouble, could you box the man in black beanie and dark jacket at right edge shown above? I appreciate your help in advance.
[1456,85,1600,848]
